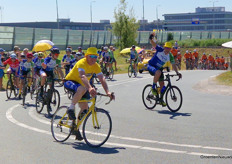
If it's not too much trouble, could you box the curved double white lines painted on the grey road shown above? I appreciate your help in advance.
[6,104,232,156]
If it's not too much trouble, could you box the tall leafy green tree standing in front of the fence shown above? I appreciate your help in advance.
[112,0,139,49]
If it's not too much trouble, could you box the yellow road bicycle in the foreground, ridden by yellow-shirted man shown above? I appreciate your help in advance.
[51,92,114,147]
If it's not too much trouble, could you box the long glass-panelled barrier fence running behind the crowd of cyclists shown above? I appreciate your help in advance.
[0,26,232,51]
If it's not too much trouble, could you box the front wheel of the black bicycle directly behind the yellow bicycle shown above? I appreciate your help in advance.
[47,89,60,116]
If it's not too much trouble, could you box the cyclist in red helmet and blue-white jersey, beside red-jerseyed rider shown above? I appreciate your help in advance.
[19,53,34,99]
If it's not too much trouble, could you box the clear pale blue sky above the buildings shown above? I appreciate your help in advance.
[0,0,232,23]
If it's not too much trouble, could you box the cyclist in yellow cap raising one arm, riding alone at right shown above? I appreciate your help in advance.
[147,33,182,106]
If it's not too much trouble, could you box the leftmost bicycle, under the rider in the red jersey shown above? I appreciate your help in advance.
[4,73,18,99]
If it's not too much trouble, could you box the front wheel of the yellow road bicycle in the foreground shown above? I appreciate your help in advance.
[82,108,112,147]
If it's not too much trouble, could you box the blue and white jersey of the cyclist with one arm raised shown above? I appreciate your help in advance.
[148,45,175,69]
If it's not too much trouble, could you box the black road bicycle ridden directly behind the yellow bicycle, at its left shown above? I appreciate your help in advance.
[35,76,62,117]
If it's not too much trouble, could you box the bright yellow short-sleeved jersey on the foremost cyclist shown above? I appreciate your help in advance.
[65,58,101,86]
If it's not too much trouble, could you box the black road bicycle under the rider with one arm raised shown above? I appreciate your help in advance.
[142,74,183,112]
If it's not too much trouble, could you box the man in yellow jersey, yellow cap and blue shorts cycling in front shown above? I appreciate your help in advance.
[64,47,114,140]
